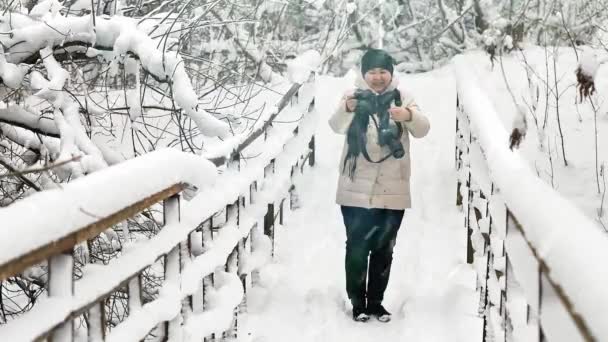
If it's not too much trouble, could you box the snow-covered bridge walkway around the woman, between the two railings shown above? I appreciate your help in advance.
[240,68,483,342]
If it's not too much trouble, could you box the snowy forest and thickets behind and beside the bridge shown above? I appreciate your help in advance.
[0,0,608,336]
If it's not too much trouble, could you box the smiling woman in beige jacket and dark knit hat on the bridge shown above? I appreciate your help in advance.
[329,49,430,322]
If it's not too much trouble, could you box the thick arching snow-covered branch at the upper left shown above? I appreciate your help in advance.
[0,13,228,137]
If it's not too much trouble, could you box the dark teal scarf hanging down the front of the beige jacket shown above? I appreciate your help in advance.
[342,91,394,179]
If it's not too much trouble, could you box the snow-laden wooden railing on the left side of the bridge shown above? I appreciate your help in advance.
[0,74,317,342]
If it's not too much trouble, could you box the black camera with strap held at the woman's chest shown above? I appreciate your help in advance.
[354,89,405,159]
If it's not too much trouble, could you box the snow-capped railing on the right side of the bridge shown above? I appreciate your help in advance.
[455,58,608,342]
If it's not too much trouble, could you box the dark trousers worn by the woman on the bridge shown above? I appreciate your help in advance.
[341,206,404,307]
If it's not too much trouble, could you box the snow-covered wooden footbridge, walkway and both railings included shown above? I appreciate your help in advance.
[0,60,608,342]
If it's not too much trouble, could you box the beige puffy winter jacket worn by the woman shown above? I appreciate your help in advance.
[329,76,430,209]
